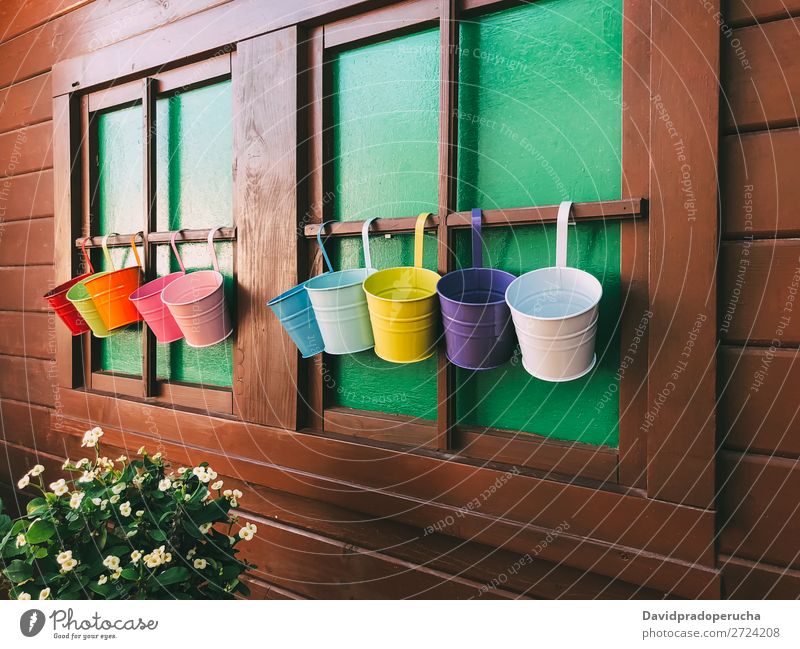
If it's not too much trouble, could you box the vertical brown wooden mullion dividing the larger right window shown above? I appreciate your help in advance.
[436,0,458,450]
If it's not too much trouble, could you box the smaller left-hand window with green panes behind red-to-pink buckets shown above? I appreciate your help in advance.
[80,58,235,412]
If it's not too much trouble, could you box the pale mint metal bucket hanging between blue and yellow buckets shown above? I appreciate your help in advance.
[306,218,375,354]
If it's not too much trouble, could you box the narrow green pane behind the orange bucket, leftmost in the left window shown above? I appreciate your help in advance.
[95,106,144,376]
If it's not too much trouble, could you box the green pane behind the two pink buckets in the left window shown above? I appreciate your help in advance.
[156,81,233,387]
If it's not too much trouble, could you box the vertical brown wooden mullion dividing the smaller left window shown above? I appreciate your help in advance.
[142,78,158,397]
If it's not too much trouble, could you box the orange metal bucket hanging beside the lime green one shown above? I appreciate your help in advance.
[86,232,144,330]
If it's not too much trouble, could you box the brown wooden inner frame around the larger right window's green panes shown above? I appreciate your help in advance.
[303,0,649,488]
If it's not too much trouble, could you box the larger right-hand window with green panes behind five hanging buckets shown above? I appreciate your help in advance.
[306,0,643,480]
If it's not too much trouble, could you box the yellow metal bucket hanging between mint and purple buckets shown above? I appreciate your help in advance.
[363,212,440,363]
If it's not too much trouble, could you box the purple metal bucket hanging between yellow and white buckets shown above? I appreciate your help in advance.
[436,209,517,370]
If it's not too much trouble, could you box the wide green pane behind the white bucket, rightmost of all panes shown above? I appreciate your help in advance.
[456,0,622,446]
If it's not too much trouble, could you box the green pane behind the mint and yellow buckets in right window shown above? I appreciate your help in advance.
[324,30,439,419]
